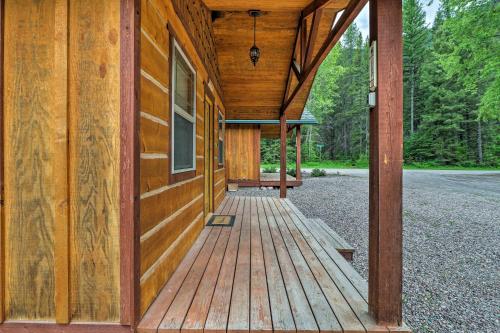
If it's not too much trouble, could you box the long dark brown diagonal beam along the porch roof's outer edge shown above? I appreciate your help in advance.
[281,0,368,113]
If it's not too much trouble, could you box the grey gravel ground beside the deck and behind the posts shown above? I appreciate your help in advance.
[229,170,500,333]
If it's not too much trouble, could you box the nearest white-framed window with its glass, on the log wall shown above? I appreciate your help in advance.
[171,40,196,173]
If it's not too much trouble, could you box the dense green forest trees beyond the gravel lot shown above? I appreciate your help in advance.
[302,0,500,167]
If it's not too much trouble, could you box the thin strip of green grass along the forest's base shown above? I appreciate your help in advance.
[261,161,500,171]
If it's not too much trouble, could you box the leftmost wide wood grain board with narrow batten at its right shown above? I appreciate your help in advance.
[4,0,67,320]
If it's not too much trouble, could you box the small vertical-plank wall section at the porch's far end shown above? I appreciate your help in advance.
[226,124,260,182]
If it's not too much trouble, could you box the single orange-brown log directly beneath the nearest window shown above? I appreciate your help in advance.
[141,177,203,234]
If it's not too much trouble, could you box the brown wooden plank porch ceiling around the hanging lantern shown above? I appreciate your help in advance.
[204,0,349,119]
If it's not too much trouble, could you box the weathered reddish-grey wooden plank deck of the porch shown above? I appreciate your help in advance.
[138,197,408,333]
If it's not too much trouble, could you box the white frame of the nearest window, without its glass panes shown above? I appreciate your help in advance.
[170,38,196,174]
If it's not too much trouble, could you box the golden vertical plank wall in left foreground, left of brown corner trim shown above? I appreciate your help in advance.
[2,0,120,323]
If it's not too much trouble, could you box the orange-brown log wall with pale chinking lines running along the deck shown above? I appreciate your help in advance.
[140,0,226,313]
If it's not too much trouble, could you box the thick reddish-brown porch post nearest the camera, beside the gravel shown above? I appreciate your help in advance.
[368,0,403,326]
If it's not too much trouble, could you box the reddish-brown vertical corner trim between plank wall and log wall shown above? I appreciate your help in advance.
[120,0,141,327]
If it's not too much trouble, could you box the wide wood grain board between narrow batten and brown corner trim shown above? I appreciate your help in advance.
[69,0,120,321]
